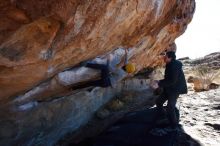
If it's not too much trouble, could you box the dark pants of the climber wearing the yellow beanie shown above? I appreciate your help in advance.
[71,63,111,90]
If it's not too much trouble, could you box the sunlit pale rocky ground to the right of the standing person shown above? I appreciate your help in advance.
[178,89,220,146]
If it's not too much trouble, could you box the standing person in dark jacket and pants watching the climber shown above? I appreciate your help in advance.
[152,51,187,129]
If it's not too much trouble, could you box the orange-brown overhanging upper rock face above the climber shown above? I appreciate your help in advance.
[0,0,195,103]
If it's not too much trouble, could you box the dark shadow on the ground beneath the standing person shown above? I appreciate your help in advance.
[69,108,201,146]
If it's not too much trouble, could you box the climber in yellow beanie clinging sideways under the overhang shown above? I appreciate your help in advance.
[71,49,135,90]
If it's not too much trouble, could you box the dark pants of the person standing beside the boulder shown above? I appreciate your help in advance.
[156,91,179,128]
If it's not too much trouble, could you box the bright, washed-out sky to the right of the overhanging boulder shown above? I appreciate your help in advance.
[176,0,220,59]
